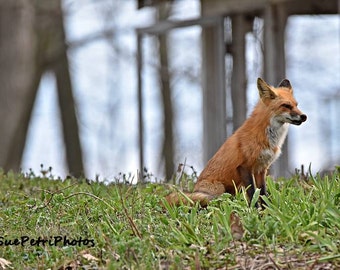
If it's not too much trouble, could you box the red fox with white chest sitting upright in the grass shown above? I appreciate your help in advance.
[166,78,307,206]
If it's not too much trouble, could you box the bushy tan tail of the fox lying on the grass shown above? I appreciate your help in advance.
[165,191,215,207]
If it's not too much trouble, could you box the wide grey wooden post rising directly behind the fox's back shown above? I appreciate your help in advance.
[202,17,227,163]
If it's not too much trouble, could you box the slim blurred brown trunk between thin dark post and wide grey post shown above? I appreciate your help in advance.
[158,2,175,181]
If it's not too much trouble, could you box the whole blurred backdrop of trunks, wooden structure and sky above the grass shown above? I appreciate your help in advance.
[0,0,340,180]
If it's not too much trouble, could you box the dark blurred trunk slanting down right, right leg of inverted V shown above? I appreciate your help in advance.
[35,0,84,177]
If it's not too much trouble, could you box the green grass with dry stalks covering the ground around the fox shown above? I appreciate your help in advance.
[0,168,340,269]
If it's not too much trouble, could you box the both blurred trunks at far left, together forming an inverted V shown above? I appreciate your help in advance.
[0,0,84,176]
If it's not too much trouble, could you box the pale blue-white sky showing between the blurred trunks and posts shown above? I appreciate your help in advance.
[22,0,340,179]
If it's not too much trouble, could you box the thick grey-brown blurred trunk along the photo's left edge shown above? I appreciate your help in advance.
[0,0,41,171]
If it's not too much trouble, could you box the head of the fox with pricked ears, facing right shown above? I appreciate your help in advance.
[257,78,307,125]
